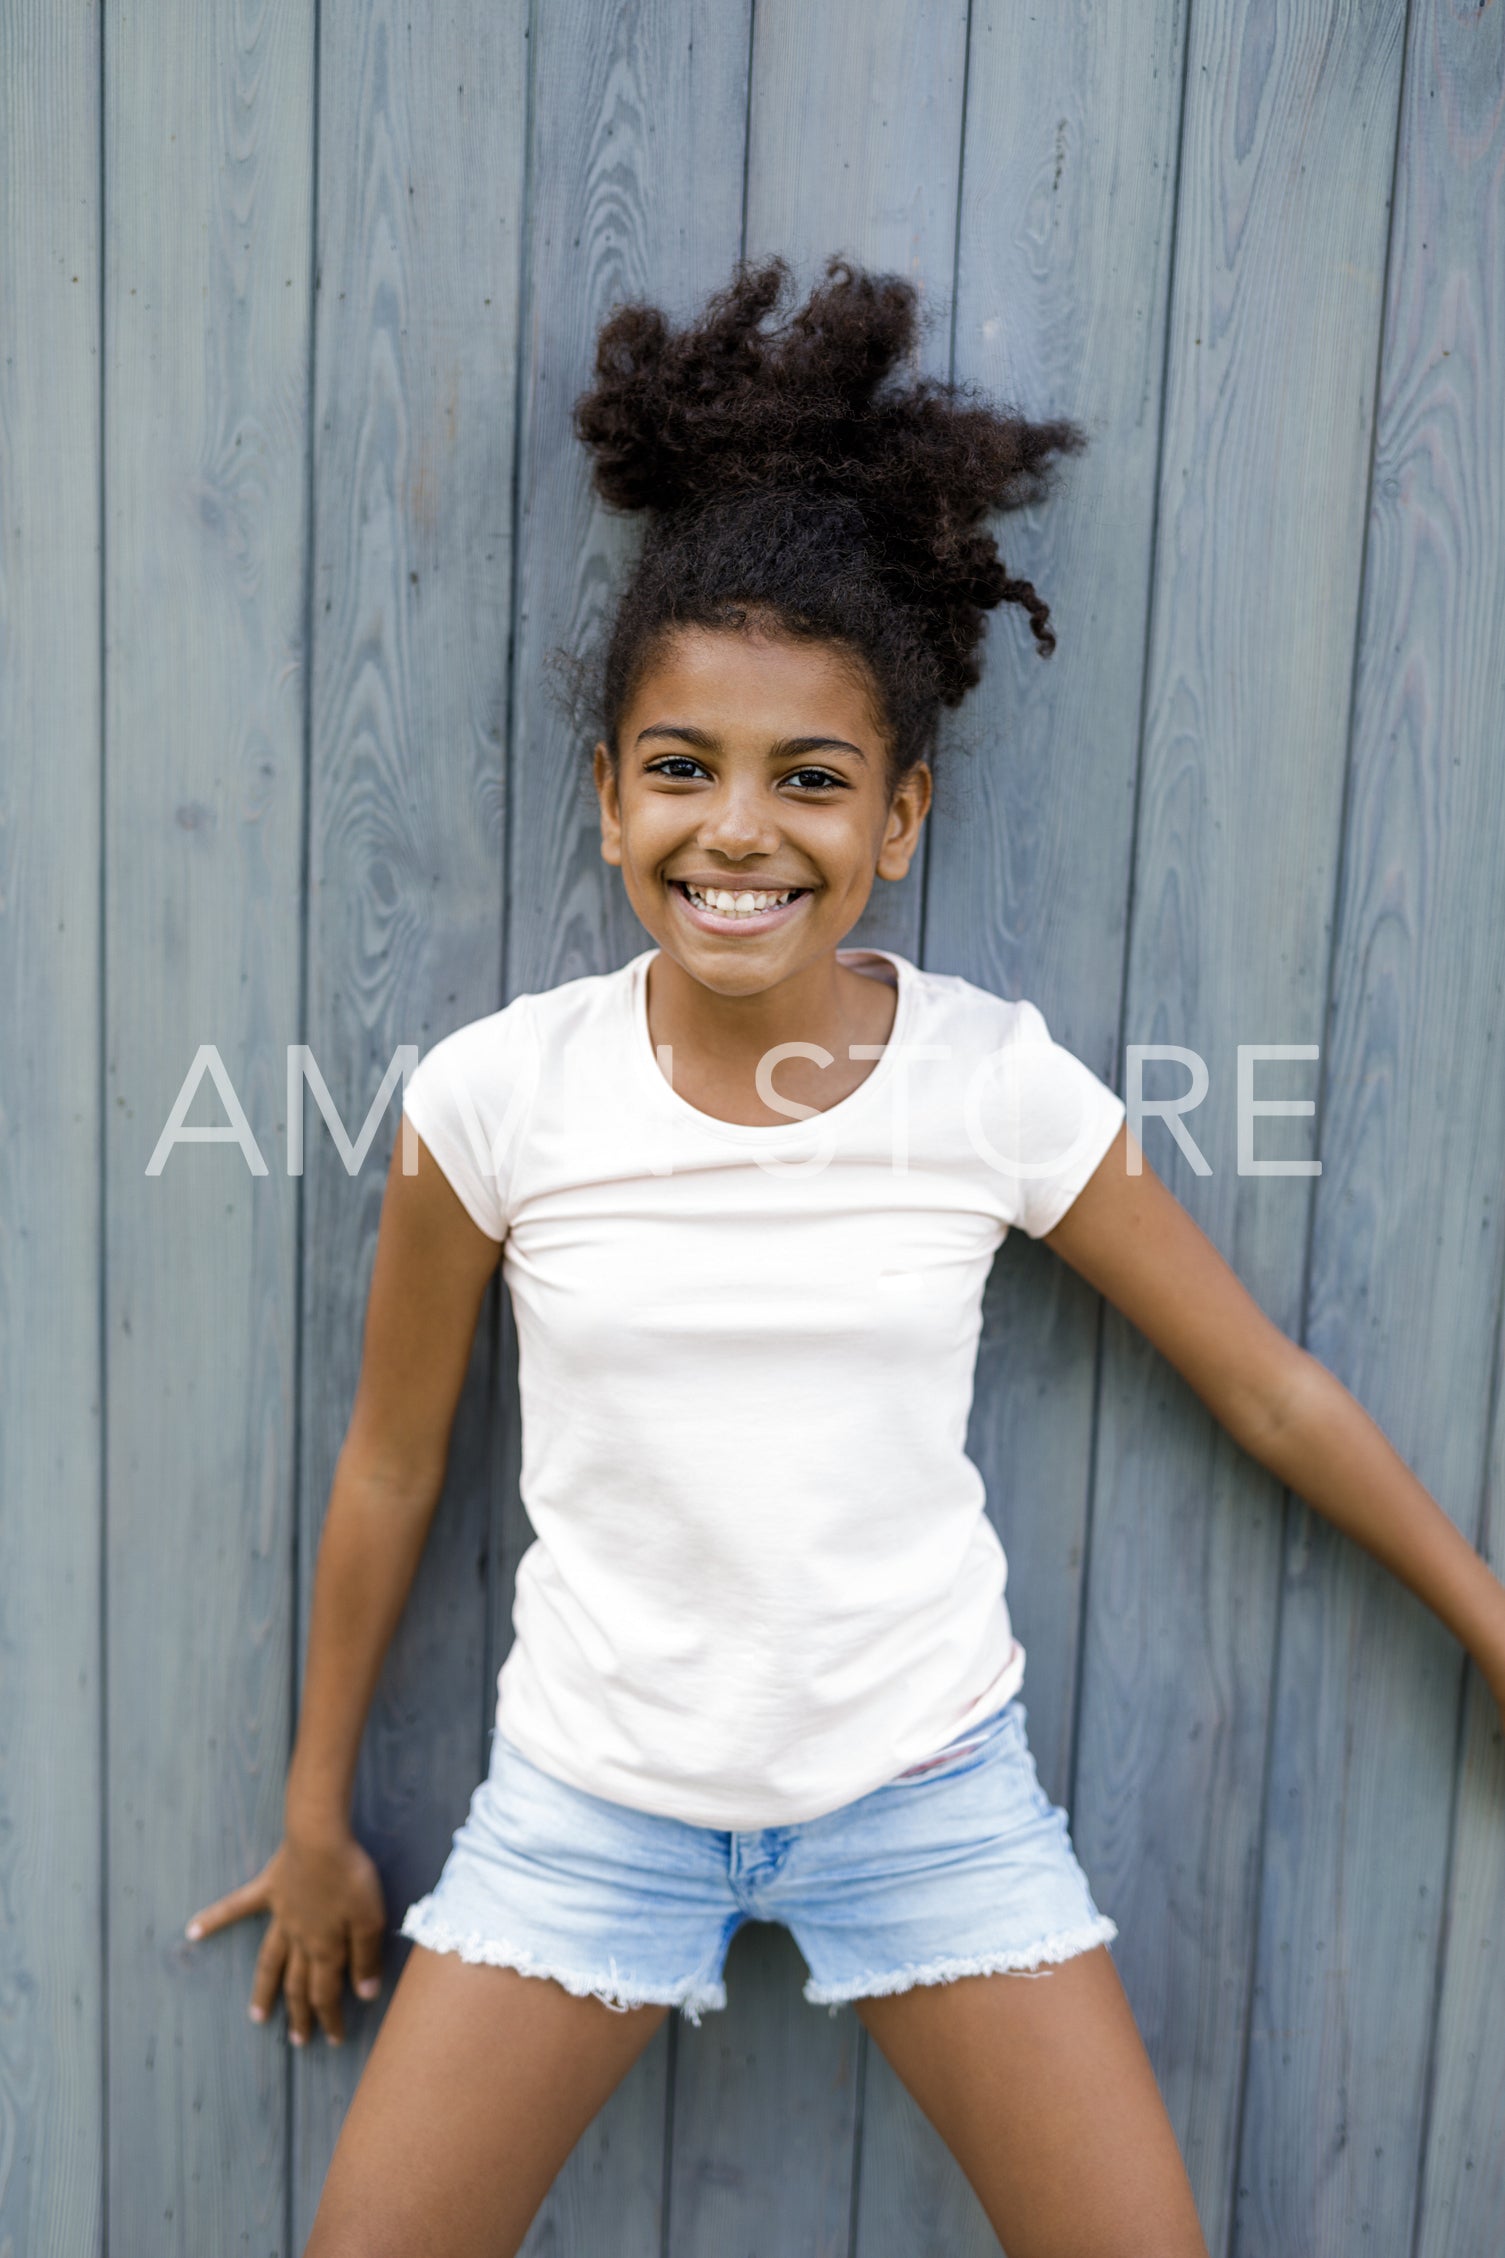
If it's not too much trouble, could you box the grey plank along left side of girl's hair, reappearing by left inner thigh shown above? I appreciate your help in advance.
[492,0,749,2258]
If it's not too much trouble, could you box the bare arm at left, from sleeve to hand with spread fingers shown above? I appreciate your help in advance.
[187,1138,501,2043]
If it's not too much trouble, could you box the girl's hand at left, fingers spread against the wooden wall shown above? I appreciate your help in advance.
[187,1829,386,2046]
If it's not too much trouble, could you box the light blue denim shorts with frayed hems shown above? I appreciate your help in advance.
[402,1696,1117,2023]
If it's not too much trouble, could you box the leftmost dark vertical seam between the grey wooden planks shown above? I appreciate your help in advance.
[95,0,111,2258]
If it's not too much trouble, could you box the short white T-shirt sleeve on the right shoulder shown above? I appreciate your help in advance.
[968,1003,1126,1240]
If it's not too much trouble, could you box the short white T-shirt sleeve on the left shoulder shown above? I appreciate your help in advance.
[402,996,539,1240]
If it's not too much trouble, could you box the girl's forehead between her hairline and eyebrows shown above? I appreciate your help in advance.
[623,628,880,745]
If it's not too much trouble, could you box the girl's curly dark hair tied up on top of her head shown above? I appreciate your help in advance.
[575,257,1083,784]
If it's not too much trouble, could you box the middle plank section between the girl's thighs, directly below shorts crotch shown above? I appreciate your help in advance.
[670,1924,860,2258]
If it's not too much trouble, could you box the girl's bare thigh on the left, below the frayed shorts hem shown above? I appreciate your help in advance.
[305,1944,668,2258]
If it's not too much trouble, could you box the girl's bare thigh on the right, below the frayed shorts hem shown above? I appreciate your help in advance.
[855,1946,1207,2258]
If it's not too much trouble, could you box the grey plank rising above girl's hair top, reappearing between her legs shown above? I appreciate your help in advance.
[694,13,968,2253]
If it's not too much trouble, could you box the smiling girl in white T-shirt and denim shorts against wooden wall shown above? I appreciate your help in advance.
[190,262,1505,2258]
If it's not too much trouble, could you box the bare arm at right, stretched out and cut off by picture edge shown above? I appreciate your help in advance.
[1047,1127,1505,1716]
